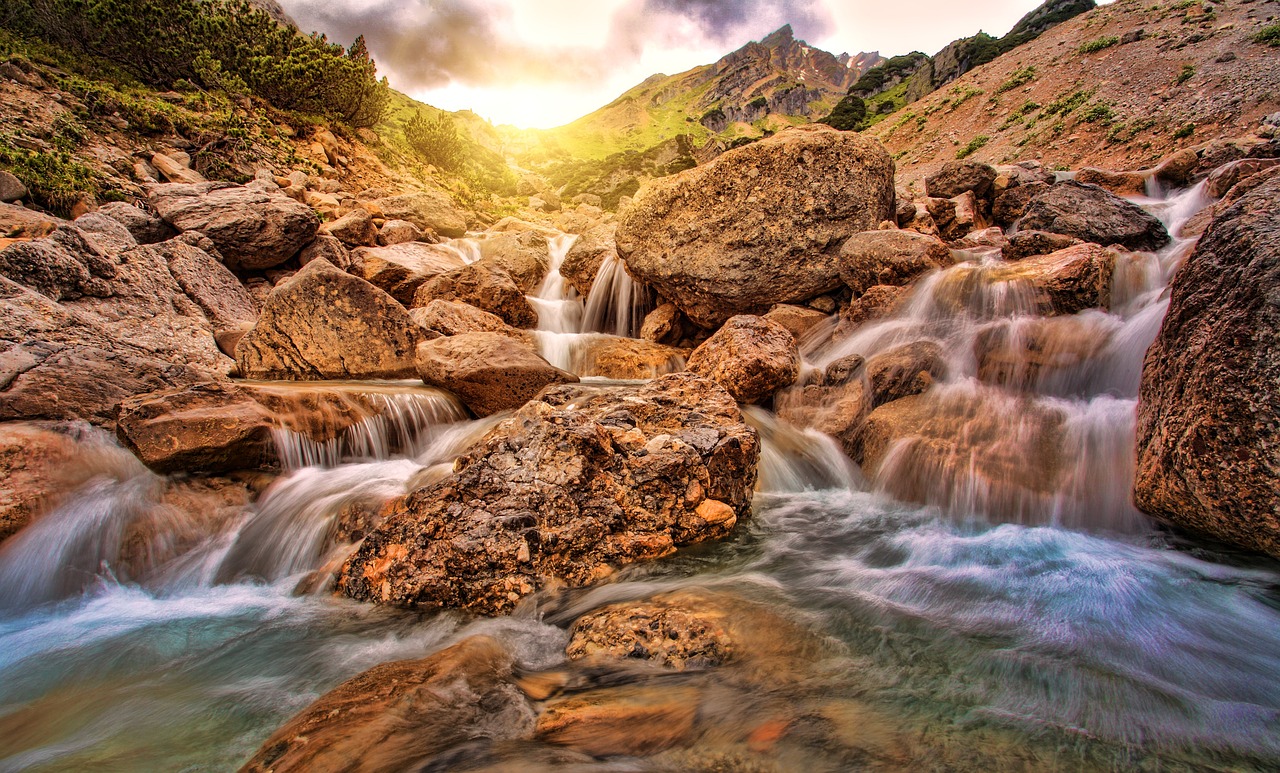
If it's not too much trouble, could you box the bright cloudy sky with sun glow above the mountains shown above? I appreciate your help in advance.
[280,0,1080,127]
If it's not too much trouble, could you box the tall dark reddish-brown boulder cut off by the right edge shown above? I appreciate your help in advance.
[1134,178,1280,557]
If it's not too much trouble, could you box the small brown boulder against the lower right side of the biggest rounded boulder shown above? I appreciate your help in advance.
[840,230,951,297]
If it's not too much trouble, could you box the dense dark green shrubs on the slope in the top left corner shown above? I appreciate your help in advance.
[0,0,390,127]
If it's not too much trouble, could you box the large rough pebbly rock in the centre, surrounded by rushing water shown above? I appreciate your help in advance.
[339,374,759,614]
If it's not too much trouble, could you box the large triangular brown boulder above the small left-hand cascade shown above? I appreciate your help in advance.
[236,260,421,380]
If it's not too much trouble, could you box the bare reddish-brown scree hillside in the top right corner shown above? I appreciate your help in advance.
[868,0,1280,185]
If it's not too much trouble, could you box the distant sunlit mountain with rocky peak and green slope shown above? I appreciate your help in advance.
[508,24,883,164]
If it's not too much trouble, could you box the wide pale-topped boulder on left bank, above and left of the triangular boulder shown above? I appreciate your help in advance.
[148,183,320,270]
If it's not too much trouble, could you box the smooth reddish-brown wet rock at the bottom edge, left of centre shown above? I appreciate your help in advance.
[242,636,534,773]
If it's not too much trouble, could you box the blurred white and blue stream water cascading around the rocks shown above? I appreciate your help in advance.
[0,184,1280,770]
